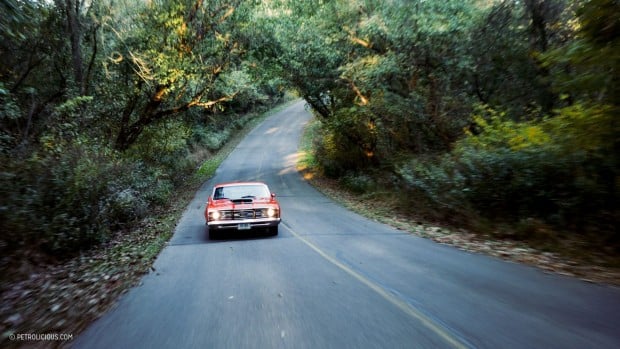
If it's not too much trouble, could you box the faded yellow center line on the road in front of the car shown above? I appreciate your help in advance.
[282,222,469,349]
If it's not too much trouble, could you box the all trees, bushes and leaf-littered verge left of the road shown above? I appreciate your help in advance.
[0,0,290,346]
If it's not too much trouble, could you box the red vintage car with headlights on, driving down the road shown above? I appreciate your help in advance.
[205,182,281,238]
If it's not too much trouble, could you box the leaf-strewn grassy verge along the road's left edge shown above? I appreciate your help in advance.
[0,94,296,347]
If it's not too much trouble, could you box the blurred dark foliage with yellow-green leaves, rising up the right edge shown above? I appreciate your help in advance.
[388,0,620,243]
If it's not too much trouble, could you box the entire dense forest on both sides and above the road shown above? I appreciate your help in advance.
[0,0,620,255]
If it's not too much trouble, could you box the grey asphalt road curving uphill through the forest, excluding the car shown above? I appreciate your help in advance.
[74,102,620,349]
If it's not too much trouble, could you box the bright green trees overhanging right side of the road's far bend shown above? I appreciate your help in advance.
[257,1,476,176]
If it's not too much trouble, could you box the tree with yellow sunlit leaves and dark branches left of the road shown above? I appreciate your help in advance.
[106,0,245,151]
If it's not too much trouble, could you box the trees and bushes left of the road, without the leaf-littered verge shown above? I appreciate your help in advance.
[0,0,284,257]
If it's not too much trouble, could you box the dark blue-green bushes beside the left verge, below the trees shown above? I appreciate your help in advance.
[0,142,179,256]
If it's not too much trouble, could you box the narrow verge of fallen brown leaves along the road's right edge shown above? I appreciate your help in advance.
[297,118,620,286]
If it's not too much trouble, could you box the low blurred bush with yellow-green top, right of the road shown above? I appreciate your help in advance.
[396,105,620,242]
